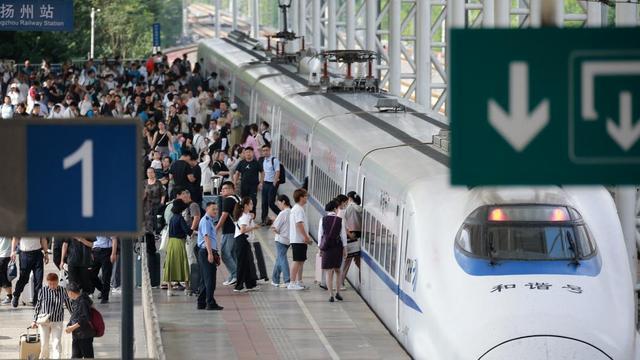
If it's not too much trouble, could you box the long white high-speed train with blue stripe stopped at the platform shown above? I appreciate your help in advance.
[198,34,640,360]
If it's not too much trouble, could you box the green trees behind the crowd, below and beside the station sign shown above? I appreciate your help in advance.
[0,0,182,63]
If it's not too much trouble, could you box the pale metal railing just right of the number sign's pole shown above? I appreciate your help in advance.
[140,241,167,360]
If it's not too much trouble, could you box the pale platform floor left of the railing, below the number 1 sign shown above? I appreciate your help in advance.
[0,264,147,359]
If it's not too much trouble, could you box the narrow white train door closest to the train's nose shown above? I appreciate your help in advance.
[398,211,417,343]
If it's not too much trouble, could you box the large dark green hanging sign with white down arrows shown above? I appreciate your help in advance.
[449,28,640,186]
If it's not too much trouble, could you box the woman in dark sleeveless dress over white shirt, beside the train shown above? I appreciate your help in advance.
[318,200,347,302]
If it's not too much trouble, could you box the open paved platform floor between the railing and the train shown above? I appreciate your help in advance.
[154,228,409,359]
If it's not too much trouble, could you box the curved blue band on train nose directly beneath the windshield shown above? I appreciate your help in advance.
[454,246,602,276]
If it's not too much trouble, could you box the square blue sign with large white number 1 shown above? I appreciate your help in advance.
[27,124,139,233]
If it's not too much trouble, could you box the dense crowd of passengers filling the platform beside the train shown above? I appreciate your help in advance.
[0,53,362,358]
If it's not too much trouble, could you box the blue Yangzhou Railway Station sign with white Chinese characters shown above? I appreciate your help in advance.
[0,0,73,31]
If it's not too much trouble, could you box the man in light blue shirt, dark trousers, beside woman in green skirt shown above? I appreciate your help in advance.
[198,202,223,310]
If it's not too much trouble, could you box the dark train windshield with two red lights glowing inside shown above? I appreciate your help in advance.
[456,205,596,261]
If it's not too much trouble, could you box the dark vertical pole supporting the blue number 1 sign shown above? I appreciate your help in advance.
[120,238,134,360]
